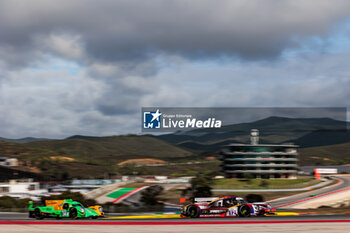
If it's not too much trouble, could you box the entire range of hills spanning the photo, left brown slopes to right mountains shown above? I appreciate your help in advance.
[0,117,350,179]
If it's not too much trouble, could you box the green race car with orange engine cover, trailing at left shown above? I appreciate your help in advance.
[28,199,99,219]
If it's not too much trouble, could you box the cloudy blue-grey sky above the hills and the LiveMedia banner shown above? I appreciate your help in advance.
[0,0,350,138]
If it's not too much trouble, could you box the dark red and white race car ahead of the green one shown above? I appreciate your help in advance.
[181,195,275,218]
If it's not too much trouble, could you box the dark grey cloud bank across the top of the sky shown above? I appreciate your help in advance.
[0,0,350,67]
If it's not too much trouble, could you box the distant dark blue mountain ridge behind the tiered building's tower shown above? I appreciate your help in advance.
[155,117,350,149]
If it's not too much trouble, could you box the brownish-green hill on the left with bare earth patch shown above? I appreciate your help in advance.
[0,135,192,179]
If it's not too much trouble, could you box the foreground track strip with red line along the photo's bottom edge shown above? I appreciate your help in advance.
[0,213,350,233]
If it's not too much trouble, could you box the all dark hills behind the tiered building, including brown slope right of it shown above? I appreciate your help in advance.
[157,117,350,165]
